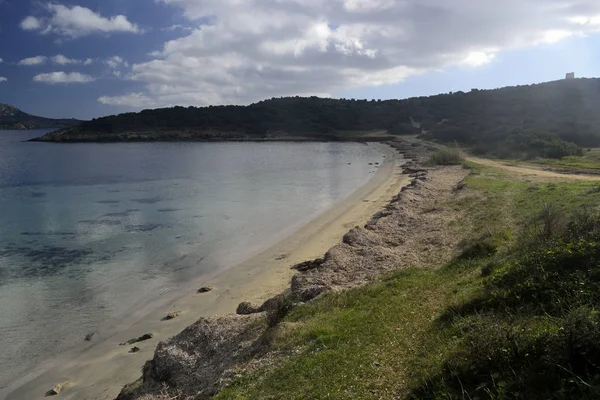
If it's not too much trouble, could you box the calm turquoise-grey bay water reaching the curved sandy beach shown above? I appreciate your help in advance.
[0,131,382,389]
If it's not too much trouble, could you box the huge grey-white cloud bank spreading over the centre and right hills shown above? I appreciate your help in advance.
[99,0,600,108]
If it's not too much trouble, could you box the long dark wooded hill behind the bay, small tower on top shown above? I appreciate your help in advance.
[30,78,600,158]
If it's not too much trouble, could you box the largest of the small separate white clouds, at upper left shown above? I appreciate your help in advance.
[21,3,142,38]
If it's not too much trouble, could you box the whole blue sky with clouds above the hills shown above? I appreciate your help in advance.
[0,0,600,119]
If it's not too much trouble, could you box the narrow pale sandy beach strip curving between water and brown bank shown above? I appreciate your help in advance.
[5,143,408,400]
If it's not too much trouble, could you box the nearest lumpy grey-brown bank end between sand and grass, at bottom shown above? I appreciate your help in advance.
[117,315,266,400]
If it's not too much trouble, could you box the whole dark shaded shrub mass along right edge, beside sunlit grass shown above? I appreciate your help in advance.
[411,206,600,400]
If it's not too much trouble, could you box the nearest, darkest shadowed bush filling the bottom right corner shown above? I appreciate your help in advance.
[418,308,600,400]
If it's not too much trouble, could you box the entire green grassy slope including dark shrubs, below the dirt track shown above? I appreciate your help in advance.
[216,164,600,400]
